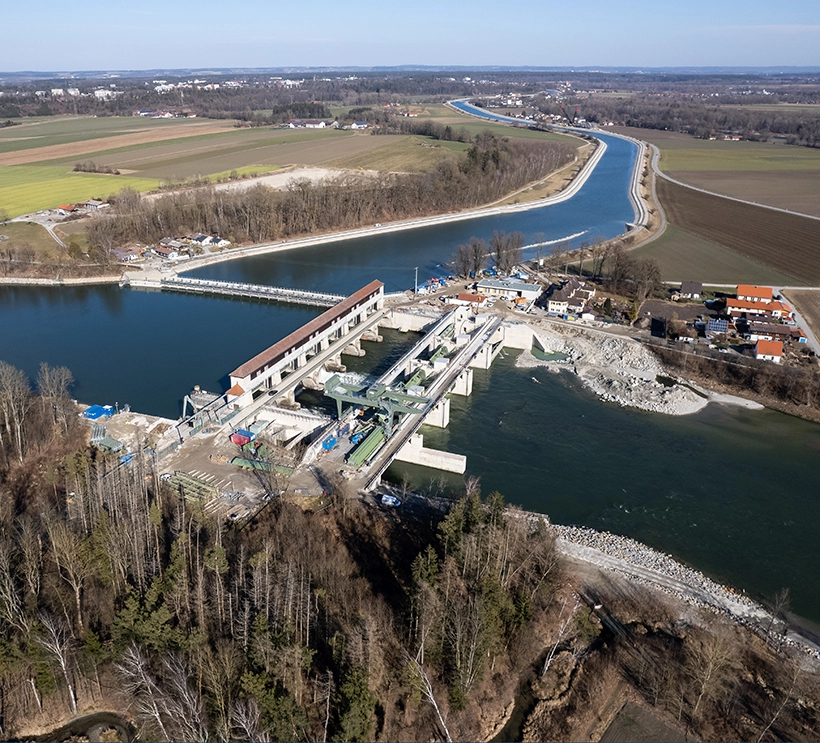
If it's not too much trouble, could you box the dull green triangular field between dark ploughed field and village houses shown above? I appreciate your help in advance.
[633,225,796,285]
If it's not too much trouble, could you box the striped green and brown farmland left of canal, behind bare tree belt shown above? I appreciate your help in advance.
[0,106,584,216]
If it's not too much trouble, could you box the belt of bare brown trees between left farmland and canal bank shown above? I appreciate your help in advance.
[81,133,575,251]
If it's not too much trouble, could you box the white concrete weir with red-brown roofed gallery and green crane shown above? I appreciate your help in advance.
[164,281,533,489]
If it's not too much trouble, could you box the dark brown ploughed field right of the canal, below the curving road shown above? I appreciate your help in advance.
[650,179,820,286]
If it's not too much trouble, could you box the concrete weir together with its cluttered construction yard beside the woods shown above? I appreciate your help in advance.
[89,281,538,522]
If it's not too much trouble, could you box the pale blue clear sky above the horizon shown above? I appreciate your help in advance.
[0,0,820,72]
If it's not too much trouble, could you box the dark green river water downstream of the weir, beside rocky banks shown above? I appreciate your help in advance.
[382,344,820,622]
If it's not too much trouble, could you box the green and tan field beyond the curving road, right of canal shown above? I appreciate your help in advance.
[614,127,820,216]
